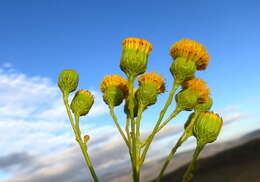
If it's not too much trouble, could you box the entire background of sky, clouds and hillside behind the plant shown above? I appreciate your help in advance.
[0,0,260,182]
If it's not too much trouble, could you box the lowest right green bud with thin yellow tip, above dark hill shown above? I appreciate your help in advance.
[193,112,223,144]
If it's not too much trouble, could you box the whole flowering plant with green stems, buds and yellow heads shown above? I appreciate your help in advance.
[58,38,222,182]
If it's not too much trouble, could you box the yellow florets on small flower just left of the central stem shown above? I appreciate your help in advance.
[100,75,128,98]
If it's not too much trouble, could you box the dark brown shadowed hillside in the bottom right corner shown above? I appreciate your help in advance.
[149,134,260,182]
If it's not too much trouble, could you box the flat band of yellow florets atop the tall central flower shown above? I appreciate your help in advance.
[123,37,152,54]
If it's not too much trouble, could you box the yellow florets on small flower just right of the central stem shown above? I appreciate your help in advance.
[138,71,165,94]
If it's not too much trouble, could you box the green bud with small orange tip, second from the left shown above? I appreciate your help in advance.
[70,90,94,116]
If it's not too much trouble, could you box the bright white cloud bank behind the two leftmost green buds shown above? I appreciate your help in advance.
[0,63,107,155]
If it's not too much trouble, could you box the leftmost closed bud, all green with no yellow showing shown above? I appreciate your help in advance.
[58,70,79,94]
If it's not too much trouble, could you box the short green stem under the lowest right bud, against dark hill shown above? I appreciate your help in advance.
[182,142,205,182]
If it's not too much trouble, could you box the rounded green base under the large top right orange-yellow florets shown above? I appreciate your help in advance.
[170,57,196,83]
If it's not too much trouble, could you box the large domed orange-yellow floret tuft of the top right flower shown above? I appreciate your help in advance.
[171,39,210,70]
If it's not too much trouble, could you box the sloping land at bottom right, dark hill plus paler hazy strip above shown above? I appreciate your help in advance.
[102,130,260,182]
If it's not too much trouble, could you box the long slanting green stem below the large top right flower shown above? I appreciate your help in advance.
[141,81,179,164]
